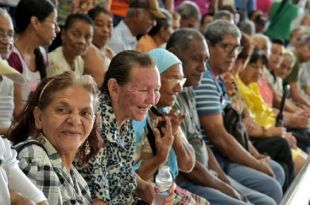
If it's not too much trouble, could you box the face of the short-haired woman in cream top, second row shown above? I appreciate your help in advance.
[61,20,94,56]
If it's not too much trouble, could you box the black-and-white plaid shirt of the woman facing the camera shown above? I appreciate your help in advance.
[16,138,92,205]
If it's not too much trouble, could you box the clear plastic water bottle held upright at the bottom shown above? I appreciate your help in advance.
[152,165,173,205]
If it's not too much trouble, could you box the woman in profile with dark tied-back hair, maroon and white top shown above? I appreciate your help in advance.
[8,0,59,117]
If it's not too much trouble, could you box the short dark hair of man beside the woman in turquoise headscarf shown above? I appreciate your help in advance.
[166,28,204,50]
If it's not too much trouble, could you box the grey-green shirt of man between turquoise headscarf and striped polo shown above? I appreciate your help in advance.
[173,87,209,183]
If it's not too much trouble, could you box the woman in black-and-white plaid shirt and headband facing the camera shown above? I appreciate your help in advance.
[10,72,99,205]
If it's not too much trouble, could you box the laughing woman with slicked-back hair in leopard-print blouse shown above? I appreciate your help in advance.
[79,50,174,205]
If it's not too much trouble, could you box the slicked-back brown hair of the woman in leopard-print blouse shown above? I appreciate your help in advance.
[101,50,155,94]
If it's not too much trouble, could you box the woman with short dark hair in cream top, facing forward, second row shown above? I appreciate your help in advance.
[47,13,94,77]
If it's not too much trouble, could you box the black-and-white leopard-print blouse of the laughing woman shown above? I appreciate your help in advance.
[78,94,136,205]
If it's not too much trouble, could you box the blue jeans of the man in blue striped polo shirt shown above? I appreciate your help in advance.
[216,153,285,204]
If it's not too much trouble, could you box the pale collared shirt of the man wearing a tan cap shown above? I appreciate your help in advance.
[109,21,137,53]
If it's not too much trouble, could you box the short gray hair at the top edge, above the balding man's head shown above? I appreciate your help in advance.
[176,1,201,20]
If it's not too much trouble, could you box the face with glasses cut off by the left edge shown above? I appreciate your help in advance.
[0,15,14,59]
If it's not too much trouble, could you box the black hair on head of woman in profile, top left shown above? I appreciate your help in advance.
[15,0,56,33]
